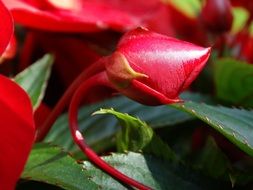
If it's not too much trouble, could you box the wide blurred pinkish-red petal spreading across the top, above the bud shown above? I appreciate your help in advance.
[3,0,174,33]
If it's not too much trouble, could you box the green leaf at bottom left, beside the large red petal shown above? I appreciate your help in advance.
[21,144,98,190]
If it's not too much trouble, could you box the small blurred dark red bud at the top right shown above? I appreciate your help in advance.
[201,0,233,33]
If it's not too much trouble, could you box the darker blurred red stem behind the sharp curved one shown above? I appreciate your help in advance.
[36,57,107,142]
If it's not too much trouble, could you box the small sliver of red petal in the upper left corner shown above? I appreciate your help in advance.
[0,1,13,56]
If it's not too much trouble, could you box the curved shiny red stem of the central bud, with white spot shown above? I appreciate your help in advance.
[69,71,151,190]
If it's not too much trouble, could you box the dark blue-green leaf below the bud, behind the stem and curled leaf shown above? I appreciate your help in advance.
[45,93,204,152]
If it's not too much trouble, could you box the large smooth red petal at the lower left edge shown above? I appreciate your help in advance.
[0,75,35,190]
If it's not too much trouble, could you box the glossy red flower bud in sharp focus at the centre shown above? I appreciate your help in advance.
[106,28,210,105]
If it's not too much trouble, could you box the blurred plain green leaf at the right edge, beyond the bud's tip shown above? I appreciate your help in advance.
[215,59,253,107]
